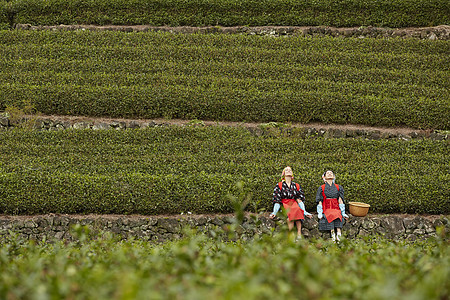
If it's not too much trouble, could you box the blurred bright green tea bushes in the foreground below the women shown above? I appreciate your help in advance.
[0,226,450,300]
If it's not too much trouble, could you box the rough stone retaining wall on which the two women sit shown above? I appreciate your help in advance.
[0,214,450,241]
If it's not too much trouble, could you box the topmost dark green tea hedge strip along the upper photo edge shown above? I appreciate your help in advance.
[0,0,450,27]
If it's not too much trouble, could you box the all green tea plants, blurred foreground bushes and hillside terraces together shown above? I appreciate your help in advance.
[0,0,450,300]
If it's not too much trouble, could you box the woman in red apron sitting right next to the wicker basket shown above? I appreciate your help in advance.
[316,171,348,241]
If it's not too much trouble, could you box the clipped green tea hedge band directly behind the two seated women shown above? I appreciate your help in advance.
[0,126,450,214]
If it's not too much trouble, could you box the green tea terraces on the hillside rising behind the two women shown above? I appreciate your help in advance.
[0,0,450,218]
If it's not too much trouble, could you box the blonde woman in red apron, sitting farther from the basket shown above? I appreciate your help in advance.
[270,167,312,240]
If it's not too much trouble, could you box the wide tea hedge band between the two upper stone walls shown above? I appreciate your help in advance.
[0,31,450,130]
